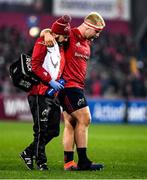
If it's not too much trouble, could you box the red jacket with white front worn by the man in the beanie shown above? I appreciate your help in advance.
[29,37,65,95]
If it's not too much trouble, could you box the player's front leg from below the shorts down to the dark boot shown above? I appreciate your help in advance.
[71,106,103,170]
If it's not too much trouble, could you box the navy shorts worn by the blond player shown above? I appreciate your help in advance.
[58,88,87,114]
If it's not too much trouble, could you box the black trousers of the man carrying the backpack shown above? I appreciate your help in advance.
[25,95,61,164]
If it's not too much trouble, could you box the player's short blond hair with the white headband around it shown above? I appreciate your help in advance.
[84,12,106,30]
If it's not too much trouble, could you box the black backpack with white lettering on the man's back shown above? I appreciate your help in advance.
[9,54,40,92]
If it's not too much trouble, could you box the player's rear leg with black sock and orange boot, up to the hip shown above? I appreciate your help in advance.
[58,89,77,170]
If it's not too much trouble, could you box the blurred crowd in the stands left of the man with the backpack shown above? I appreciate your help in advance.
[0,26,33,94]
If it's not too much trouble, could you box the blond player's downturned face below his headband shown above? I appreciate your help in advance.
[85,28,101,41]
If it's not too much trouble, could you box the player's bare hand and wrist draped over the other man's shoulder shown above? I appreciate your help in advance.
[40,29,56,47]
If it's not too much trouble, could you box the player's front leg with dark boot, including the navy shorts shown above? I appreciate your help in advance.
[59,88,102,170]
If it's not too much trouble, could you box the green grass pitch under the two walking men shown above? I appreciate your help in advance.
[0,122,147,179]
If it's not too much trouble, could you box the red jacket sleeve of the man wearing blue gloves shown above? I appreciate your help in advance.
[31,38,51,84]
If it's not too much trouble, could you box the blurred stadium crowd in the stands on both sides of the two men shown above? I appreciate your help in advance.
[0,26,147,98]
